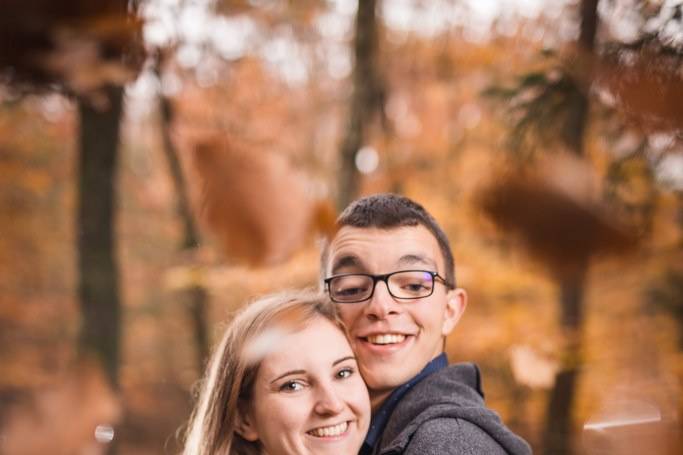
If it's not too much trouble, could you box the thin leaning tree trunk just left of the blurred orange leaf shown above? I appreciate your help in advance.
[154,55,209,376]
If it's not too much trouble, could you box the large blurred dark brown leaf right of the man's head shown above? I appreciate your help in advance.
[478,155,638,274]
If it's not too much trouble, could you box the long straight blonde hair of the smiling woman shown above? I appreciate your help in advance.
[183,290,343,455]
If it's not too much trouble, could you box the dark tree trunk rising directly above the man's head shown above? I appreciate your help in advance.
[337,0,384,210]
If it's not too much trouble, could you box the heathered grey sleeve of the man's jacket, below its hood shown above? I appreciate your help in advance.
[403,417,507,455]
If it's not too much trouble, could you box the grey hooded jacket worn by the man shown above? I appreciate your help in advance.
[375,363,531,455]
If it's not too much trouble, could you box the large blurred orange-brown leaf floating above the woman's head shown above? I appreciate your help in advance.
[194,140,332,265]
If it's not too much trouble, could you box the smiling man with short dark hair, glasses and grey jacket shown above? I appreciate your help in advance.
[321,194,531,455]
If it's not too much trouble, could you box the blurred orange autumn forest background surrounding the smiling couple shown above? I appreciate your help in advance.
[0,0,683,455]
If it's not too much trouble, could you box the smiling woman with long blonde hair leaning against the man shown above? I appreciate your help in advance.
[184,292,370,455]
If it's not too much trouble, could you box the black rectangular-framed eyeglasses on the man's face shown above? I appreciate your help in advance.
[325,270,454,303]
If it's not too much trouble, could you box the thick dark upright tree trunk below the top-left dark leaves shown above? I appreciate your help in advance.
[77,87,123,388]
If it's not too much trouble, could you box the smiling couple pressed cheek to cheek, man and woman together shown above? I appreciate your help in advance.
[184,194,531,455]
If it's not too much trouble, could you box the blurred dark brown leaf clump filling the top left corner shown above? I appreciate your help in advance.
[0,0,144,98]
